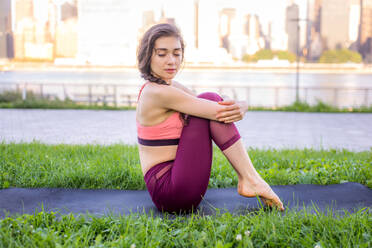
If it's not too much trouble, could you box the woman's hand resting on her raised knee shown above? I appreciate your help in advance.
[216,99,248,123]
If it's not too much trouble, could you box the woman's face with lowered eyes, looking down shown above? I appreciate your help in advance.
[151,36,182,84]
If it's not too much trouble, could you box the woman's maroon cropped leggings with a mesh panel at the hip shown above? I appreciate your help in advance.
[145,92,240,212]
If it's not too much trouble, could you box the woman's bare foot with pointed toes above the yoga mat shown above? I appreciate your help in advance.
[238,178,284,211]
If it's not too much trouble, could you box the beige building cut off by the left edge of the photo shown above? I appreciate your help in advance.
[0,0,14,59]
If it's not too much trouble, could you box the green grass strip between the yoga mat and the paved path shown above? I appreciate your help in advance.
[0,143,372,189]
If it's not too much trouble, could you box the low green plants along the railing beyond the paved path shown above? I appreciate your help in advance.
[0,91,372,113]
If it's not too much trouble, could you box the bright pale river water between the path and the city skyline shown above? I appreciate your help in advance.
[0,70,372,107]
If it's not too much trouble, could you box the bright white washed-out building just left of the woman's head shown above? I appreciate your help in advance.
[77,0,143,65]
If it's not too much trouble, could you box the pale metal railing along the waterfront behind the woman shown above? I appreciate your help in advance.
[0,82,372,107]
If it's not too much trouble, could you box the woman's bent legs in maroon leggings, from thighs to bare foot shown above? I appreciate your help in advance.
[155,93,282,212]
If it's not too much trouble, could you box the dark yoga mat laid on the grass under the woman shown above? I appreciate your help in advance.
[0,183,372,218]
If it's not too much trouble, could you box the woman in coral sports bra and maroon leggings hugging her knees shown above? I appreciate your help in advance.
[136,24,284,212]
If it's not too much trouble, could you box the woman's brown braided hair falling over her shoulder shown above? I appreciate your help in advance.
[137,23,185,84]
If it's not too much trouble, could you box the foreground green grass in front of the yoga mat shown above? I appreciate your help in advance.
[0,210,372,248]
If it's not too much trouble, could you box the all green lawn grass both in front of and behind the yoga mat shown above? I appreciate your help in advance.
[0,143,372,248]
